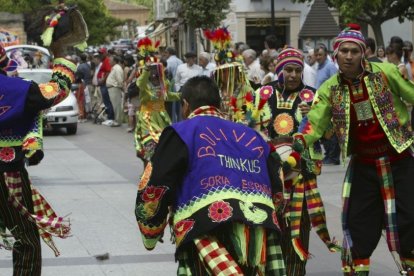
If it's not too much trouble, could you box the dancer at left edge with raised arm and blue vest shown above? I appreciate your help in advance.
[0,42,76,276]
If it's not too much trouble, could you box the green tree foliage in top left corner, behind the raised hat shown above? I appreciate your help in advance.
[0,0,123,45]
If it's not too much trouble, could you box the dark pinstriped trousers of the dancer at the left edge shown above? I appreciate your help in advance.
[0,168,42,276]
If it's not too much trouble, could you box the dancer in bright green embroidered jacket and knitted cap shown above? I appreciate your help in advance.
[296,24,414,275]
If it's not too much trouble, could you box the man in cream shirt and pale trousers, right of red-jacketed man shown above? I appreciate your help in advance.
[106,55,124,127]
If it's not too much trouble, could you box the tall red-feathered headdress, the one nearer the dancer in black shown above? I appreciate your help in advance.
[204,27,235,64]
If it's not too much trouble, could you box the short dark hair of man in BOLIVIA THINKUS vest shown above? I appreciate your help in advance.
[181,76,221,110]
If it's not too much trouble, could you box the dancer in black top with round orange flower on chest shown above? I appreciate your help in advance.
[253,47,339,276]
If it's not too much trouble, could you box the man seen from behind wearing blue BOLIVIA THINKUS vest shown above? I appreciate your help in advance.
[135,76,285,275]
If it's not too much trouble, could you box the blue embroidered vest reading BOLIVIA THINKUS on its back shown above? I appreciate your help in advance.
[172,116,277,247]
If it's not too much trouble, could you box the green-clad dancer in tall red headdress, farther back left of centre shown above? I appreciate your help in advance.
[135,37,180,167]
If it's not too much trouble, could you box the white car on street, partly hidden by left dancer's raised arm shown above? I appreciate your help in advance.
[17,69,79,134]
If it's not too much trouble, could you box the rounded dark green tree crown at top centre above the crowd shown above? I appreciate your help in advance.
[178,0,230,29]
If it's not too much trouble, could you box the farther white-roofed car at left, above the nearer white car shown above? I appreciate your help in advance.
[5,44,52,69]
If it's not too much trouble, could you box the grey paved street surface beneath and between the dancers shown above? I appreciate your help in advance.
[0,122,398,276]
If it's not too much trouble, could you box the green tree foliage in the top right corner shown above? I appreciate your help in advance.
[292,0,414,45]
